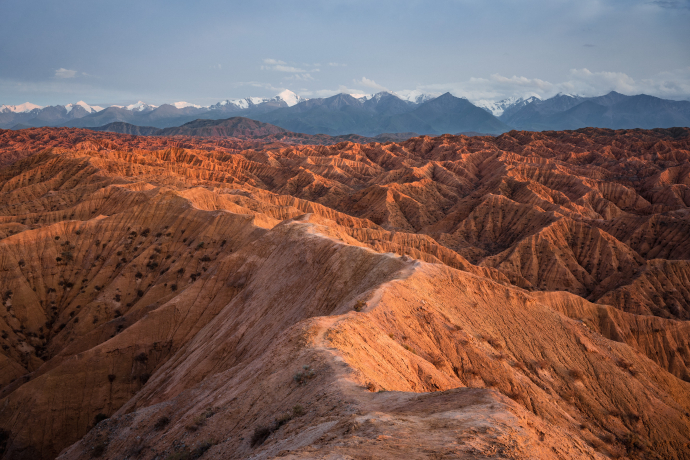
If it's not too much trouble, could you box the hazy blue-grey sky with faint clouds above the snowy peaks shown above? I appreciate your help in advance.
[0,0,690,106]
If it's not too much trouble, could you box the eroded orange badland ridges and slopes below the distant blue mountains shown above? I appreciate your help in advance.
[0,128,690,459]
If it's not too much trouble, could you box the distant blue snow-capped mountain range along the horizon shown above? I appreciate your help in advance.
[0,90,690,136]
